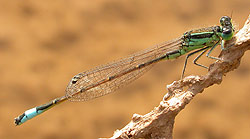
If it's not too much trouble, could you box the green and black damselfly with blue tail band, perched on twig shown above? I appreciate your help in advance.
[15,16,234,125]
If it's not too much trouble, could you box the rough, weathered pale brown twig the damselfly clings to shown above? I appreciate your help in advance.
[104,15,250,139]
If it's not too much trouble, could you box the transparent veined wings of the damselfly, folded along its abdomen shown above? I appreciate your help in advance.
[66,38,183,101]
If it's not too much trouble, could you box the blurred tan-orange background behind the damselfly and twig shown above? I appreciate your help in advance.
[0,0,250,139]
